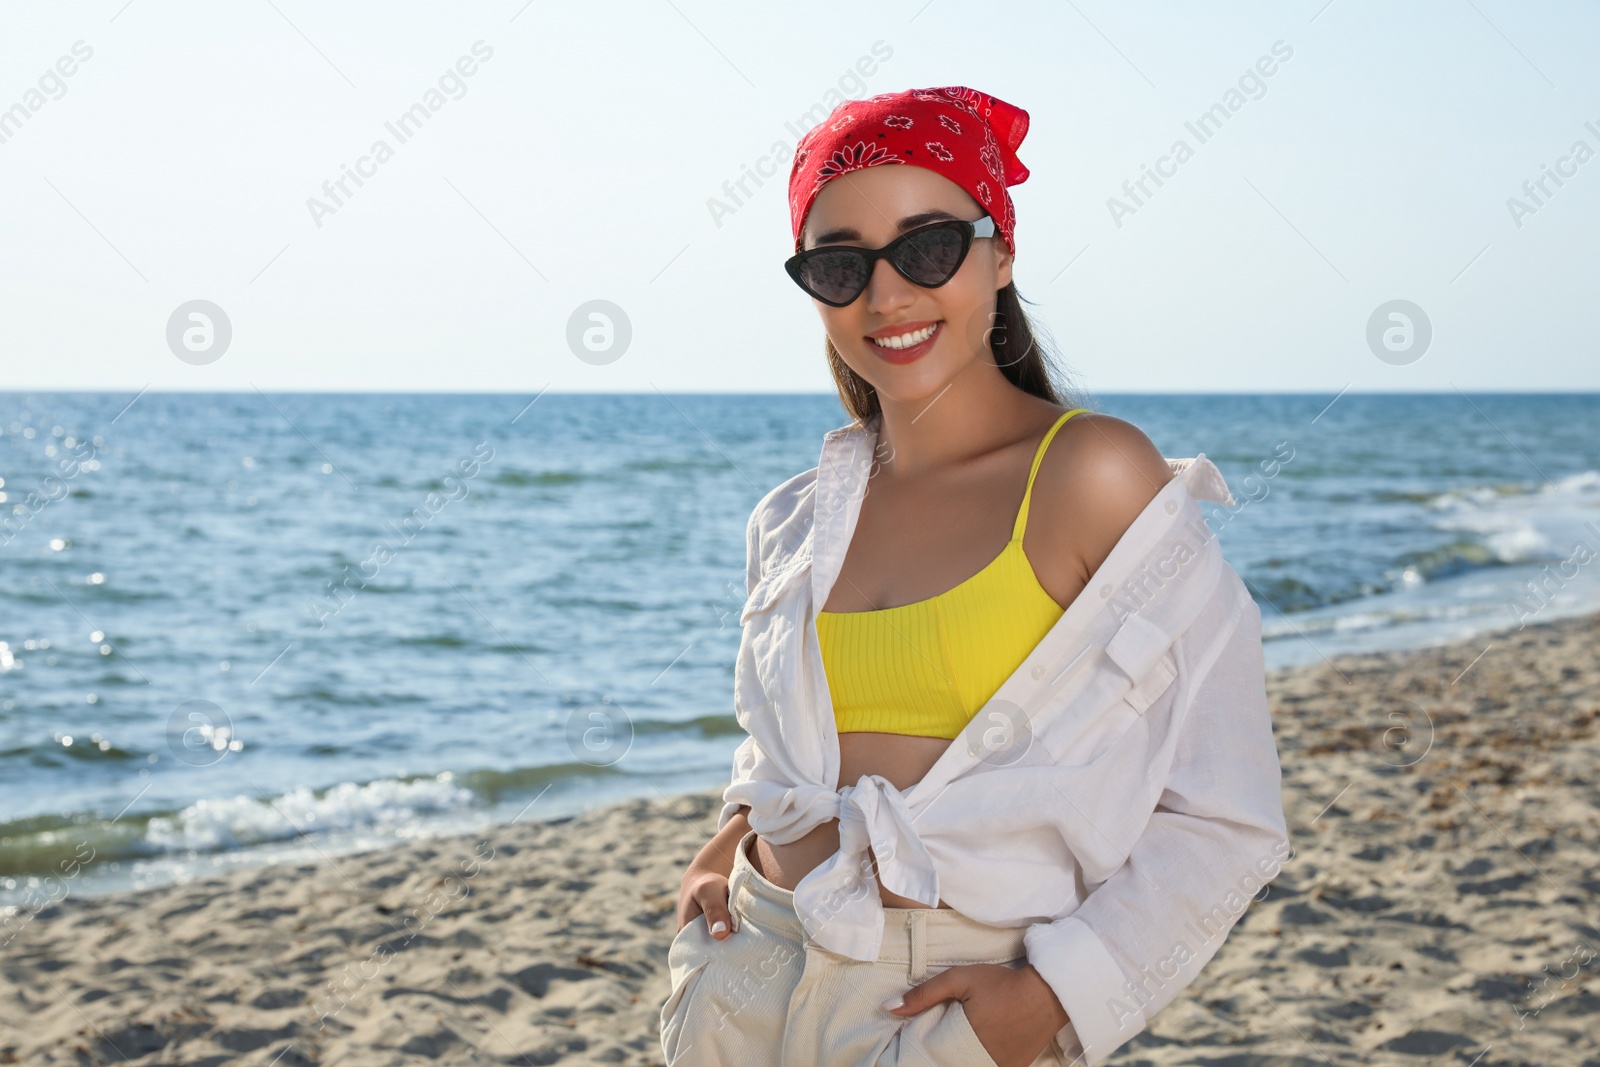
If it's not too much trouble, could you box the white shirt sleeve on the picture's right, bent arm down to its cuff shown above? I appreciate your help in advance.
[1024,591,1290,1067]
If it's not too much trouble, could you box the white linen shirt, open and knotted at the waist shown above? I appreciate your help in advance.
[717,416,1290,1067]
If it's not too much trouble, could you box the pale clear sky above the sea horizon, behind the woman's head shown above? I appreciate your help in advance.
[0,0,1600,394]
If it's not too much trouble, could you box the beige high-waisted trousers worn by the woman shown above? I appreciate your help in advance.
[661,830,1082,1067]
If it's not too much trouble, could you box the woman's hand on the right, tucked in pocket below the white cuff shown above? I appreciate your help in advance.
[891,963,1069,1067]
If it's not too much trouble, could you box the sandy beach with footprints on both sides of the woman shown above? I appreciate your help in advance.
[0,616,1600,1067]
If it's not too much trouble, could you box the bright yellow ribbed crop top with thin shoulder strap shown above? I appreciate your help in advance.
[816,408,1086,739]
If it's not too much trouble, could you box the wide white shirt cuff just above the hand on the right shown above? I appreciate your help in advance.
[1022,915,1146,1067]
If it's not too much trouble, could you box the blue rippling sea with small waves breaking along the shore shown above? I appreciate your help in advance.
[0,390,1600,908]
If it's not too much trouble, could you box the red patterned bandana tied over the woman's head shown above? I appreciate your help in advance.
[789,85,1027,256]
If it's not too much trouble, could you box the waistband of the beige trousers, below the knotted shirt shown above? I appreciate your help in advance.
[728,830,1027,971]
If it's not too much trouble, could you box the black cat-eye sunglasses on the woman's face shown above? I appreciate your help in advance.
[784,214,995,307]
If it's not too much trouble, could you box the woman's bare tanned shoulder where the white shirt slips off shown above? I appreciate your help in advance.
[1029,411,1174,579]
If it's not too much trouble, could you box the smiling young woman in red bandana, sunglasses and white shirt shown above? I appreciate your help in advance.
[661,86,1286,1067]
